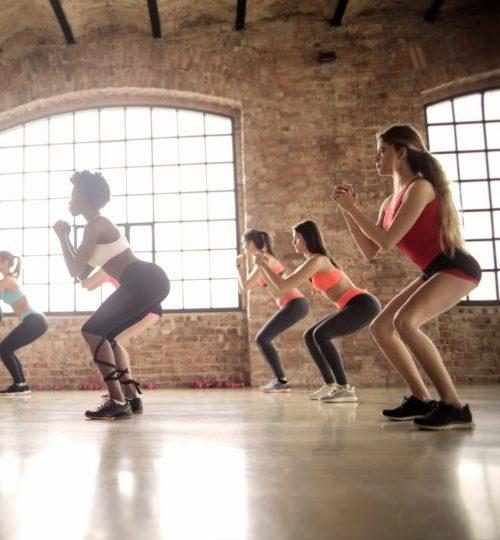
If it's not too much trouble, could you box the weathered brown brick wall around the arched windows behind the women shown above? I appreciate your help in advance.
[0,3,500,386]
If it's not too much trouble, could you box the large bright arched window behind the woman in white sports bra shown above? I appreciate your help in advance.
[0,106,239,313]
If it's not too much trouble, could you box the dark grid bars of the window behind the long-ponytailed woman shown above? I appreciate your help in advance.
[426,89,500,304]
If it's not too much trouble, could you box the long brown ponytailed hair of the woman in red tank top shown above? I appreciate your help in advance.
[377,125,464,255]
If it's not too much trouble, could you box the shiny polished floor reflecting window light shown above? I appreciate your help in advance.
[0,386,500,540]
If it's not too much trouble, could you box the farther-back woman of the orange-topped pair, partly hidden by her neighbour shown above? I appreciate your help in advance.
[236,229,309,393]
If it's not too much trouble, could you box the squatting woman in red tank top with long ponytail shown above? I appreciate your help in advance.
[332,125,481,430]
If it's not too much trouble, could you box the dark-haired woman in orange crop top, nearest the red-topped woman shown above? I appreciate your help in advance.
[254,221,380,403]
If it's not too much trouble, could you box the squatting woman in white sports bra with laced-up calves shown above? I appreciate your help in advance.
[54,171,170,420]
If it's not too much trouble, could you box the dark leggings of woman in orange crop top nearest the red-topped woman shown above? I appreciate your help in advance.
[304,293,381,385]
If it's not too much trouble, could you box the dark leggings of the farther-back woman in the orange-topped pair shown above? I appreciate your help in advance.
[255,298,309,379]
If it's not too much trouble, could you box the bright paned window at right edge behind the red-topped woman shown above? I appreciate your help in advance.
[425,89,500,303]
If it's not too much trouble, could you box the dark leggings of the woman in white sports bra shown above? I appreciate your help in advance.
[82,261,170,346]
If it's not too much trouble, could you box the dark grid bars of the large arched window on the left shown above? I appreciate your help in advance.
[0,107,241,314]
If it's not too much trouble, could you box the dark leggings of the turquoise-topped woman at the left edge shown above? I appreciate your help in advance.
[0,313,49,383]
